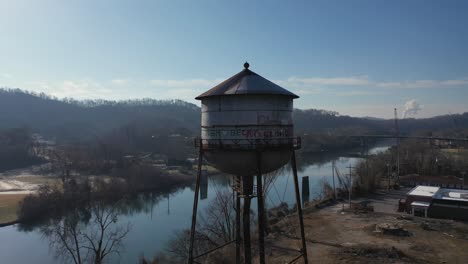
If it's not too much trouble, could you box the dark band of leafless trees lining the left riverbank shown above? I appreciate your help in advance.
[17,165,192,224]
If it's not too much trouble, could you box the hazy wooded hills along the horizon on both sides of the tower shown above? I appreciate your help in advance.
[0,89,468,141]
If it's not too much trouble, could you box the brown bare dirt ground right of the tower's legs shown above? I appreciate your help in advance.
[266,191,468,264]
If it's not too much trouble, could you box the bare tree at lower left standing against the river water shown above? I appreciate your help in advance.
[43,203,130,264]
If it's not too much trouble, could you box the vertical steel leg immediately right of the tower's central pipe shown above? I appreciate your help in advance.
[257,152,265,264]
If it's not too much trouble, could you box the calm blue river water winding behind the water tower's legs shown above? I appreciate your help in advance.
[0,145,388,264]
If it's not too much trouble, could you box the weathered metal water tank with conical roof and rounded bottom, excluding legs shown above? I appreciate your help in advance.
[196,63,300,176]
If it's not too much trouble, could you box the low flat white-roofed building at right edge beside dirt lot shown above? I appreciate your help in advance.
[405,186,468,221]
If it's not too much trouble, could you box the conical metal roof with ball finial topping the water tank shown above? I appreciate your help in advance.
[195,62,299,100]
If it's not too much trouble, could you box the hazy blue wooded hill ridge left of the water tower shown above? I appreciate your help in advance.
[0,89,200,140]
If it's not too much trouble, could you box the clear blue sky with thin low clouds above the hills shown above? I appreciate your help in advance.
[0,0,468,117]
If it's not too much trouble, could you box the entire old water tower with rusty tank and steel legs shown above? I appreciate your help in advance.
[188,63,307,264]
